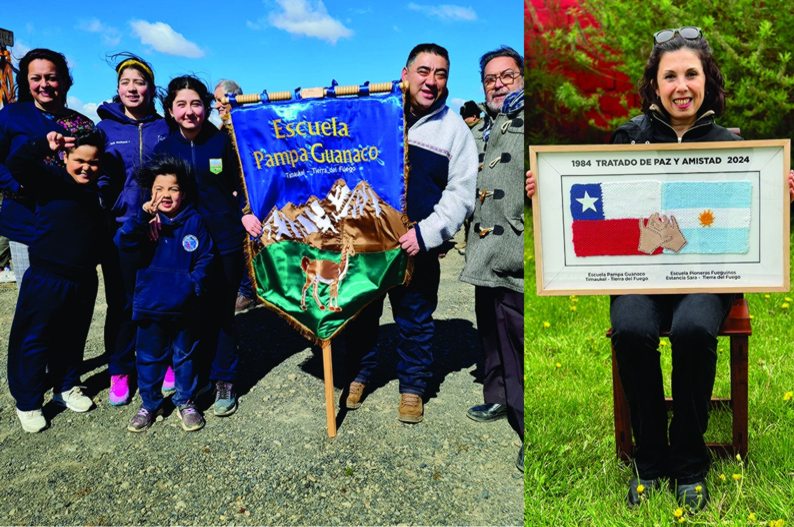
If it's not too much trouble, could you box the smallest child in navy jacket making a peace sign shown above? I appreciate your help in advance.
[115,156,212,432]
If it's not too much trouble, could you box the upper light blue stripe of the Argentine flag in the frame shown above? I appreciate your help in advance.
[662,181,753,210]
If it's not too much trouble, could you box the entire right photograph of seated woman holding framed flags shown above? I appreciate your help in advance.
[524,0,794,527]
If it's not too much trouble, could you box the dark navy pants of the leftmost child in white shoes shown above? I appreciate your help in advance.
[8,264,97,411]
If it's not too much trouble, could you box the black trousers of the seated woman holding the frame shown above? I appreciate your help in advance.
[610,294,733,484]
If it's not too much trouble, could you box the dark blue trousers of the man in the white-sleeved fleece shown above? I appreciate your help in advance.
[345,252,441,396]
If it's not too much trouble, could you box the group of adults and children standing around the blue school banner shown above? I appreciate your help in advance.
[0,44,524,470]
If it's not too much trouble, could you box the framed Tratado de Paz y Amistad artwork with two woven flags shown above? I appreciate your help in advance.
[530,139,790,295]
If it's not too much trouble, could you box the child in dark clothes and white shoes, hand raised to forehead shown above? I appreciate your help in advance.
[6,131,105,432]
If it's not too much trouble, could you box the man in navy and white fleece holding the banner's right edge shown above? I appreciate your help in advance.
[345,44,478,423]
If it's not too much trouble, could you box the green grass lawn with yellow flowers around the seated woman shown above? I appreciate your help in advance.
[524,214,794,527]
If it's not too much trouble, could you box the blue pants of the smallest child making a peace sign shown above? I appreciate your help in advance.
[135,316,199,412]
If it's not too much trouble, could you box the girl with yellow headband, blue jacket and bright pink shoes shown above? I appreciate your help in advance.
[97,53,169,406]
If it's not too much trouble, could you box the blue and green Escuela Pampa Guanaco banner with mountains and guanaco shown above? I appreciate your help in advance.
[226,83,408,341]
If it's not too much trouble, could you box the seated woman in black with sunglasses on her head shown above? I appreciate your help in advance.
[525,26,794,511]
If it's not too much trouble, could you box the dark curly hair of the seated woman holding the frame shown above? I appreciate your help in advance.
[639,34,725,116]
